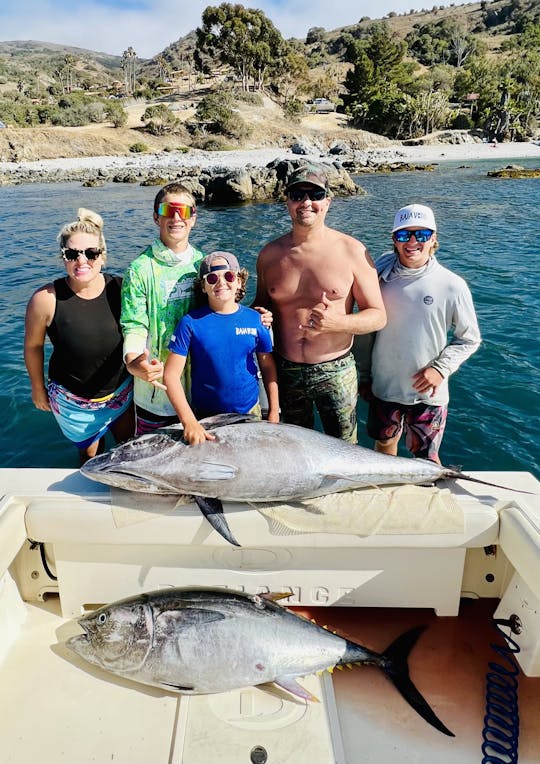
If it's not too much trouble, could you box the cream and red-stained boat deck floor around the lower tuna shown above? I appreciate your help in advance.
[0,597,540,764]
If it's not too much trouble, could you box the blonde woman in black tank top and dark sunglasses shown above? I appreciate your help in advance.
[24,208,134,464]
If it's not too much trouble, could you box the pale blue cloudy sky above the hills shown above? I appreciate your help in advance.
[0,0,472,58]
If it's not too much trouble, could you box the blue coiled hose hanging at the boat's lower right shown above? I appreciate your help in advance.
[482,615,521,764]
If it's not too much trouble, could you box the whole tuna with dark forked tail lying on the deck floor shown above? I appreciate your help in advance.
[67,589,453,735]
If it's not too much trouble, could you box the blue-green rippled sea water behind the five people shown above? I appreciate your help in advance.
[0,160,540,476]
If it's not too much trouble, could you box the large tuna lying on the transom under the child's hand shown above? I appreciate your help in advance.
[81,414,520,545]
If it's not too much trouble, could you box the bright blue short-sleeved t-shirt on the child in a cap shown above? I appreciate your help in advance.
[169,305,272,416]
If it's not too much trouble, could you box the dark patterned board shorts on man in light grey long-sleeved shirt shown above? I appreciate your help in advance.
[367,397,448,461]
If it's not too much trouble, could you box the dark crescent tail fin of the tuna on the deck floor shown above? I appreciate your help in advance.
[377,626,455,737]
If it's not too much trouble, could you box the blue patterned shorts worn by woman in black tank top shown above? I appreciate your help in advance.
[47,376,133,448]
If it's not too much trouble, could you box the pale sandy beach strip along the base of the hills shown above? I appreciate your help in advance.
[0,141,540,175]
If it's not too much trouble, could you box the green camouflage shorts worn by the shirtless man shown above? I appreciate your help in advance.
[274,351,358,443]
